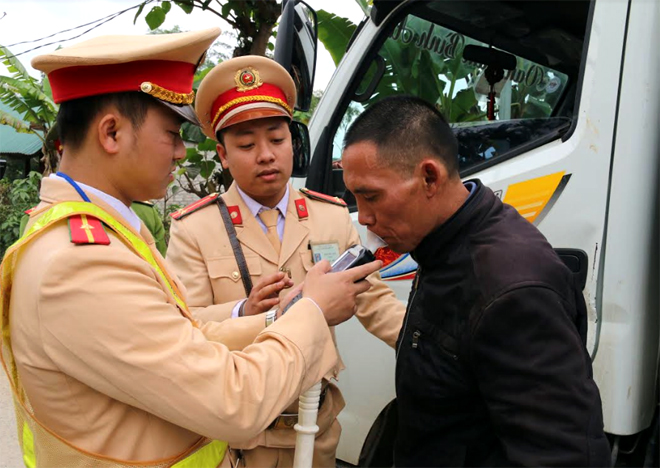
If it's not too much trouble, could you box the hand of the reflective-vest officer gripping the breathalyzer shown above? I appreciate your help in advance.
[303,260,383,326]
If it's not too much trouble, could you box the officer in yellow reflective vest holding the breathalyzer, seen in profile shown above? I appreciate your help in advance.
[0,28,380,468]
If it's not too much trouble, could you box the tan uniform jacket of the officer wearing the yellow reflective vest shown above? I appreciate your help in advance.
[10,179,338,465]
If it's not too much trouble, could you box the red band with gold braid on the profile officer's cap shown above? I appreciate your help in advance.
[48,60,195,104]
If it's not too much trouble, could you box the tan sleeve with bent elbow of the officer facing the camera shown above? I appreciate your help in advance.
[167,216,238,322]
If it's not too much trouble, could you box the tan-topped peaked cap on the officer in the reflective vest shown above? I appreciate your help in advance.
[32,28,220,123]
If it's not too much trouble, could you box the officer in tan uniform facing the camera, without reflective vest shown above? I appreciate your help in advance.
[167,56,405,467]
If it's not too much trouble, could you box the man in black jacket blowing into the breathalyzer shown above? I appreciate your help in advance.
[343,97,610,467]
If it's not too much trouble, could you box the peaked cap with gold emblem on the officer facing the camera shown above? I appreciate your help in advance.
[195,55,296,140]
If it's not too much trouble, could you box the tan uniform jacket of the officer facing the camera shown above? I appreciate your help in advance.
[167,185,405,448]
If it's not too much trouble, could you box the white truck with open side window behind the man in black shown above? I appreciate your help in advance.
[276,0,660,460]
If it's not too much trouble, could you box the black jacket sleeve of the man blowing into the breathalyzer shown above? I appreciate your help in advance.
[470,287,609,466]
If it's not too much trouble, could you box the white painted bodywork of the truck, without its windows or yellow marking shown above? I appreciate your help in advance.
[295,0,660,464]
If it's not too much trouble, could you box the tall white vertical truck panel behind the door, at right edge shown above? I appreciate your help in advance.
[594,0,660,435]
